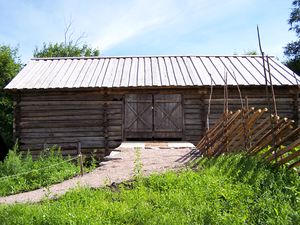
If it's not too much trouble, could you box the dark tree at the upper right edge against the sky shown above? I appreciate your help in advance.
[284,0,300,74]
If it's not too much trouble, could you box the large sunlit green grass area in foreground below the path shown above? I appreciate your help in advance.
[0,155,300,224]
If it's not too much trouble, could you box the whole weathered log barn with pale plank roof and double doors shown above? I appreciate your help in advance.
[5,55,300,156]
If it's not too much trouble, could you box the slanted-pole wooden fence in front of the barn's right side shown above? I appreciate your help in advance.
[197,108,300,171]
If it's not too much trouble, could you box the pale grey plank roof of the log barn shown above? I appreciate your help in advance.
[5,56,300,90]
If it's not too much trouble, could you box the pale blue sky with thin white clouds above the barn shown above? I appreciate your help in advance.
[0,0,295,63]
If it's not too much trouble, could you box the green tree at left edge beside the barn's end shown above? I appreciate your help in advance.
[0,45,22,149]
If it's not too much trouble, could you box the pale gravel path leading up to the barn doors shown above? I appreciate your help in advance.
[0,145,194,204]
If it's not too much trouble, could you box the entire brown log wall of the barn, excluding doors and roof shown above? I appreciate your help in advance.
[14,86,299,157]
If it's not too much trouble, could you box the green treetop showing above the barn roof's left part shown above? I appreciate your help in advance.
[33,41,100,58]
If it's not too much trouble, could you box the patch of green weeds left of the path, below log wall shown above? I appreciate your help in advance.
[0,146,95,196]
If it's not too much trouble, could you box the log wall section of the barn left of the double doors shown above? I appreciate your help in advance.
[15,89,123,158]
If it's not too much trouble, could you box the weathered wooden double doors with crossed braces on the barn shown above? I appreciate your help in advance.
[124,94,183,140]
